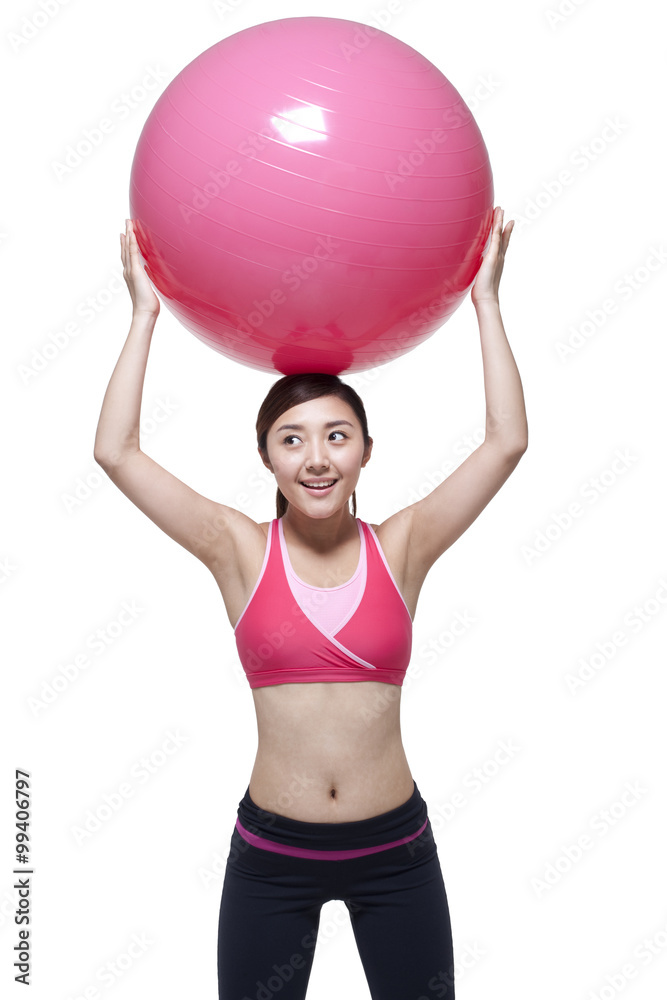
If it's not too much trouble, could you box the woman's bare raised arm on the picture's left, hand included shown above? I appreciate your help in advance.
[93,219,247,575]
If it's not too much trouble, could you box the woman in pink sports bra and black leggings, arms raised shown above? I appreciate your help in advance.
[95,208,527,1000]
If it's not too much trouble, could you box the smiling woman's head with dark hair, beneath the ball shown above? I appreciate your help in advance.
[256,372,373,517]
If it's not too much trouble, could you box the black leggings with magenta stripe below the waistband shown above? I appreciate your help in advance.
[218,783,454,1000]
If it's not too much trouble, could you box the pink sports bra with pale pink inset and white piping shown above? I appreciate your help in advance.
[234,518,412,688]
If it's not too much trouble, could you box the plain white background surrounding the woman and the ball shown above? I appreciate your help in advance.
[0,0,667,1000]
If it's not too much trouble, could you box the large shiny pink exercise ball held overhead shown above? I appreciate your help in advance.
[130,17,493,375]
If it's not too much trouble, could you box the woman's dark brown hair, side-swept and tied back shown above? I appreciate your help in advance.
[255,372,370,517]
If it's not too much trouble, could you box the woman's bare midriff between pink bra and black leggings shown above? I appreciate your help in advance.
[249,681,414,823]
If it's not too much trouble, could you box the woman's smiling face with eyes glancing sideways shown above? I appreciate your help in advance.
[263,396,373,517]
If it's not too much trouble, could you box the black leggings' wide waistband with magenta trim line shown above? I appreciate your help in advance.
[236,780,428,861]
